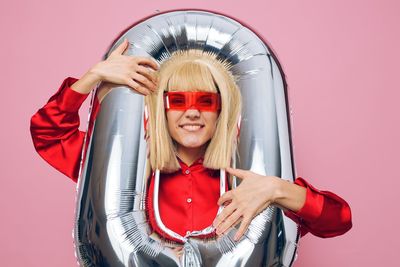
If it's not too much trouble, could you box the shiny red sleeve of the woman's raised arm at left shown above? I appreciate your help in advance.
[30,77,89,182]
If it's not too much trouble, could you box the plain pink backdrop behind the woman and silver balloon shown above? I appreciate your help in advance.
[0,0,400,267]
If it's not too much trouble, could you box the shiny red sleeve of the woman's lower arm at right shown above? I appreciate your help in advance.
[285,177,352,238]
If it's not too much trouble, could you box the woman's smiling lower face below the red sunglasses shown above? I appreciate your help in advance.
[167,107,218,152]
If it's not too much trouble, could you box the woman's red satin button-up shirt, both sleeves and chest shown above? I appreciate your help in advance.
[30,77,352,241]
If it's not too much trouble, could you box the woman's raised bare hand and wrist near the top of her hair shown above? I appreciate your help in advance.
[71,39,158,95]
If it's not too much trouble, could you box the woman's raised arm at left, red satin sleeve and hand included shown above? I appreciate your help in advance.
[30,40,158,181]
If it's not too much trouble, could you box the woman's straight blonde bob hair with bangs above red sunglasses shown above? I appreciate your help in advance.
[145,49,242,172]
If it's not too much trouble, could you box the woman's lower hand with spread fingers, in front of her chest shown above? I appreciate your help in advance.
[213,168,281,241]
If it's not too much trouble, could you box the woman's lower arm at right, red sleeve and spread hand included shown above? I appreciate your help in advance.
[213,168,352,240]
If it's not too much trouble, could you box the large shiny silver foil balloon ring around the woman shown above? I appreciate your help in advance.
[74,10,299,267]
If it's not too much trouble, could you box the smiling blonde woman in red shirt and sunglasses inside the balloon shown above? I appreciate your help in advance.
[31,40,351,247]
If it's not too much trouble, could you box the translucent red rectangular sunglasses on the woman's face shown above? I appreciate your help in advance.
[164,92,221,112]
